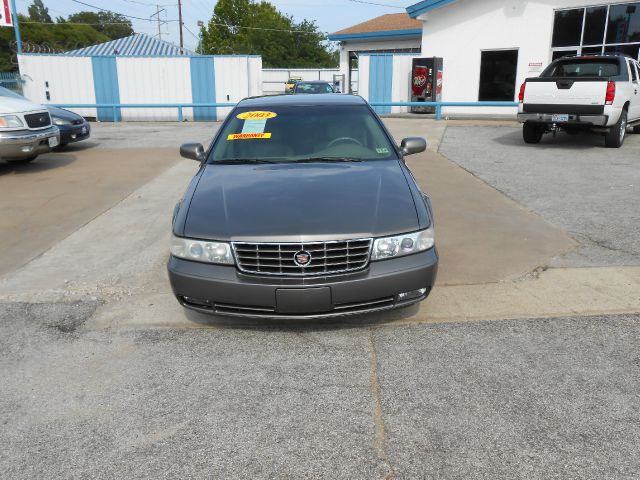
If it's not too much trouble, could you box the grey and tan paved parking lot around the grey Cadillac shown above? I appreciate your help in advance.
[0,119,640,479]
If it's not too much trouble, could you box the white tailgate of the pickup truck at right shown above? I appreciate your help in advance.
[523,78,608,113]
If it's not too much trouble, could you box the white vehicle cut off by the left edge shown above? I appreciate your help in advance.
[0,97,60,163]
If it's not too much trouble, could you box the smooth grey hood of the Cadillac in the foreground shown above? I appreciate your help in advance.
[184,160,419,241]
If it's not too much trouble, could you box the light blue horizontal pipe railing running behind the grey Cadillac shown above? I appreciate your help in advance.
[51,102,518,122]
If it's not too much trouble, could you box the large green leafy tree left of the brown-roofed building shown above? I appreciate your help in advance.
[201,0,337,68]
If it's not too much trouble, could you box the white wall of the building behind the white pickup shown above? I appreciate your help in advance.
[418,0,619,114]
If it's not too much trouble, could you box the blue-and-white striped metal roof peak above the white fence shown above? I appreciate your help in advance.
[64,33,196,57]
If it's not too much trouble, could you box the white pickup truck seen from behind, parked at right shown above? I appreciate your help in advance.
[518,54,640,148]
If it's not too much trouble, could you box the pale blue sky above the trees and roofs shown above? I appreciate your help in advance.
[16,0,417,50]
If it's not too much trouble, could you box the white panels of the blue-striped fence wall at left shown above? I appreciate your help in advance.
[19,54,262,121]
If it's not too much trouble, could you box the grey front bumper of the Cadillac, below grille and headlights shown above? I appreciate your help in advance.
[167,248,438,319]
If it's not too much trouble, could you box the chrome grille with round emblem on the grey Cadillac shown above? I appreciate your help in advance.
[233,238,372,276]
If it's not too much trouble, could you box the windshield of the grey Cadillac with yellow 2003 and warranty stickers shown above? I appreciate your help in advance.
[209,105,398,163]
